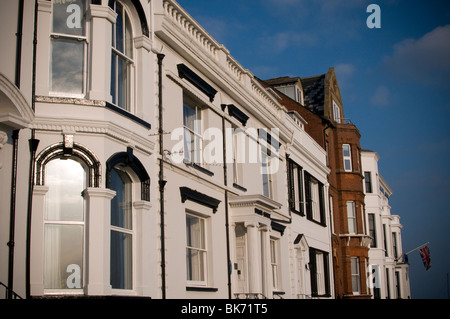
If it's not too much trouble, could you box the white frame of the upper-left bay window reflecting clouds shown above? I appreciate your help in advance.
[48,0,90,98]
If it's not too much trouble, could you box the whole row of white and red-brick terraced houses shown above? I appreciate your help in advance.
[0,0,409,299]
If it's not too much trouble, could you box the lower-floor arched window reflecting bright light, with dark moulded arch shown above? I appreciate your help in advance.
[33,143,101,294]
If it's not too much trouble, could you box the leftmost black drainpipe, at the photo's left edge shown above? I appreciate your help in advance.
[7,0,24,299]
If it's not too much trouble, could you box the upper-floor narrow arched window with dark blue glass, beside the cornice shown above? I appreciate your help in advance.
[111,1,134,111]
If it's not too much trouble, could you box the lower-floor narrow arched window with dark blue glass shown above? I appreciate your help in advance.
[110,167,133,289]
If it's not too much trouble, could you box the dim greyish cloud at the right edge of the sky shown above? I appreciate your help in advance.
[384,25,450,85]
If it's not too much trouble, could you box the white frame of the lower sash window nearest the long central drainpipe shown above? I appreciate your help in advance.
[185,211,209,287]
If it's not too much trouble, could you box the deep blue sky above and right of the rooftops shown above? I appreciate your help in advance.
[178,0,450,299]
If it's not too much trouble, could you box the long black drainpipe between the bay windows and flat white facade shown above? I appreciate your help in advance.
[157,53,167,299]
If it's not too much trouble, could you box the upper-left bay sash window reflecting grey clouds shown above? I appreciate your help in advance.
[50,0,88,97]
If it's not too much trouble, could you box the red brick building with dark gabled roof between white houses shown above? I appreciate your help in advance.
[264,68,371,298]
